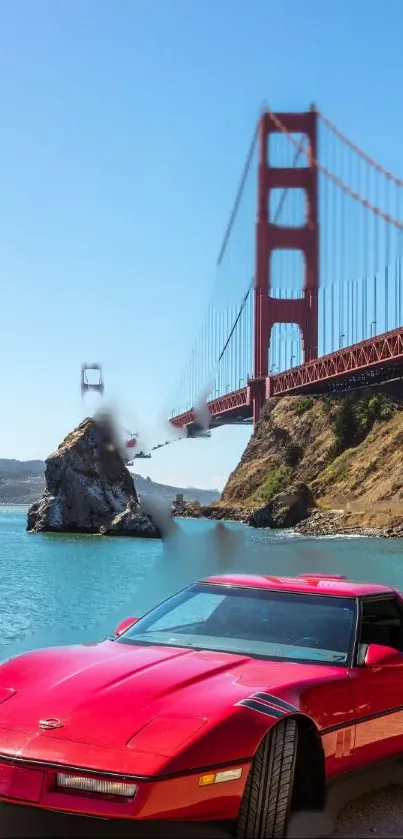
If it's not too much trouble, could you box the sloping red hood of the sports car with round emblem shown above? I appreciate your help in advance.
[0,641,340,755]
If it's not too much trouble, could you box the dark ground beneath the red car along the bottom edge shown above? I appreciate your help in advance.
[0,786,403,839]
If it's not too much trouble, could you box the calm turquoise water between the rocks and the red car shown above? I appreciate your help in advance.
[0,507,403,660]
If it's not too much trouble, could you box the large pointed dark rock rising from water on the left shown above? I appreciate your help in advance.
[27,418,160,538]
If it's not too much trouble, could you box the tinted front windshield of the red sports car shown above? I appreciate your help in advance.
[117,583,356,665]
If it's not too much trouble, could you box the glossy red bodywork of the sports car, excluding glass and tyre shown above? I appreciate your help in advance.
[0,575,403,821]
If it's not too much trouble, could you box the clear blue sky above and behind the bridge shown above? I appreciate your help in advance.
[0,0,403,487]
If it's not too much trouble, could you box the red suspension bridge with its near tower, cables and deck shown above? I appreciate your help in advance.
[166,106,403,436]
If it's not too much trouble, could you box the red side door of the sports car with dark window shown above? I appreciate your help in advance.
[350,595,403,768]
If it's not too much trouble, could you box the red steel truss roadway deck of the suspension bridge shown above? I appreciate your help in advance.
[170,327,403,437]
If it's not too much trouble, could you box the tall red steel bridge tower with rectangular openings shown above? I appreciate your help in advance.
[249,107,319,423]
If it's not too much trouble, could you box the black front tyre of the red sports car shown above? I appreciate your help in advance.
[236,719,298,839]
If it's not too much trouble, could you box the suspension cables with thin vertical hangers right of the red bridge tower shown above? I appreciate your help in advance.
[318,106,403,355]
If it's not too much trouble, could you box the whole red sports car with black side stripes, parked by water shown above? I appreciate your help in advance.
[0,574,403,839]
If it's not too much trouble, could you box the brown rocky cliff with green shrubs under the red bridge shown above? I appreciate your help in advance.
[218,384,403,535]
